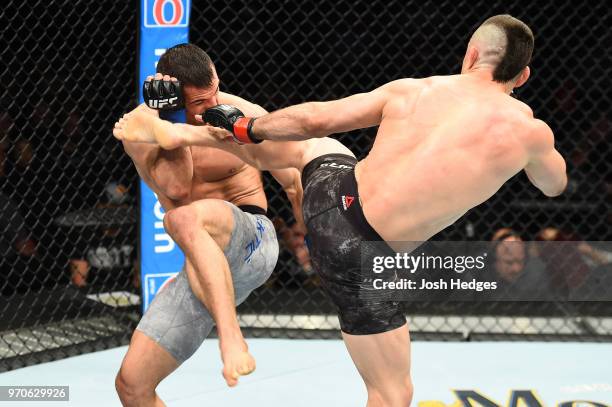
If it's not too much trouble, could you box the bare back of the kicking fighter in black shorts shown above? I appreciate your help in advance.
[356,75,535,241]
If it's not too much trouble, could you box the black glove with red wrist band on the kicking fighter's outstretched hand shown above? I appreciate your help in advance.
[202,105,263,144]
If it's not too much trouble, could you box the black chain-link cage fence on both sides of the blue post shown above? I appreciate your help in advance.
[0,0,612,370]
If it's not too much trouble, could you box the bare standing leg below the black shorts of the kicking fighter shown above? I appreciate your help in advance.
[342,324,412,407]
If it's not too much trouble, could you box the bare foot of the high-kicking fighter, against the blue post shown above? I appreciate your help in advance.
[113,108,181,150]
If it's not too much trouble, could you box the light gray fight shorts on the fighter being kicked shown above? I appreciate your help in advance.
[136,203,278,365]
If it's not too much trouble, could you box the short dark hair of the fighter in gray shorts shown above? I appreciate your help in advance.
[157,43,214,88]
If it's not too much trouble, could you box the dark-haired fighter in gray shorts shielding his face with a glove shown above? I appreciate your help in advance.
[116,44,302,406]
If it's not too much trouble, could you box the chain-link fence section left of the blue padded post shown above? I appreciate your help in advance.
[0,1,140,370]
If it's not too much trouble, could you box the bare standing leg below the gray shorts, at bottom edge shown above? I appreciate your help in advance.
[115,330,178,407]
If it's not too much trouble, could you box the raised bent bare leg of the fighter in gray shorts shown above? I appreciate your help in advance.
[164,199,255,386]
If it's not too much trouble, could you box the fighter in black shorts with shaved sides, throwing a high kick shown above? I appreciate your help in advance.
[115,15,567,407]
